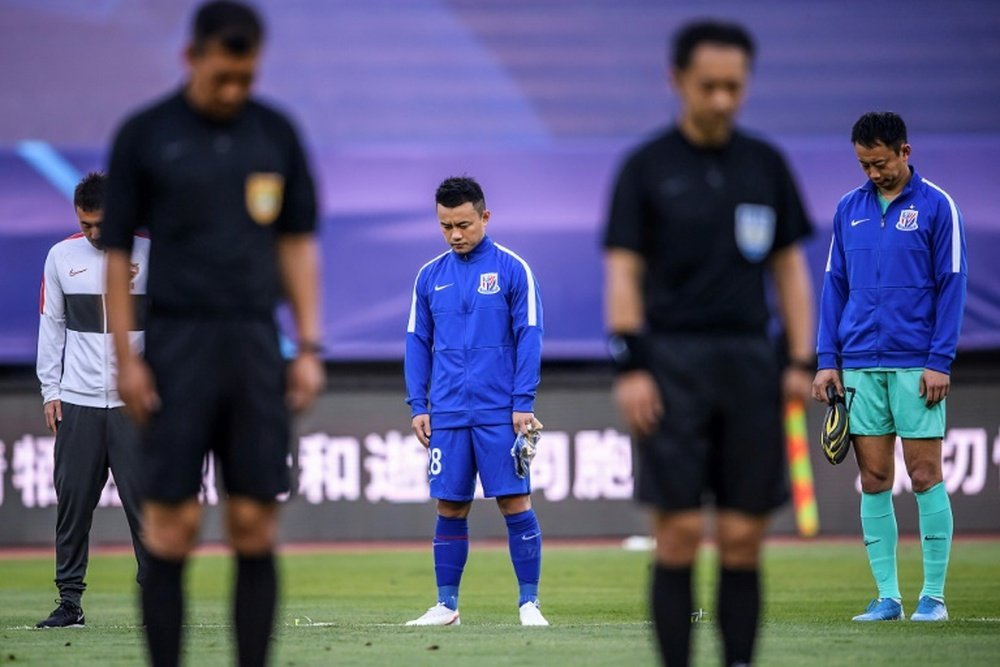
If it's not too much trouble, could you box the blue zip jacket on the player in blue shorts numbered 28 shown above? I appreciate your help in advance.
[404,236,542,428]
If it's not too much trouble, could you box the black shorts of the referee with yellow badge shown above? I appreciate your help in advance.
[143,316,290,503]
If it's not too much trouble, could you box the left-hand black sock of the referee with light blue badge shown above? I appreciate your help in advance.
[652,564,692,667]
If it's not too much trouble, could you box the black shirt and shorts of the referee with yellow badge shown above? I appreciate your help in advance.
[103,91,316,503]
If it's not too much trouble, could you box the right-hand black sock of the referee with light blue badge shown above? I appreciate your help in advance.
[719,567,760,665]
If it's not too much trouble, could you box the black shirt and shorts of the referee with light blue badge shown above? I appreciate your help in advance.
[604,128,811,514]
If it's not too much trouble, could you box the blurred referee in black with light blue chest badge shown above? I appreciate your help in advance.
[604,22,813,666]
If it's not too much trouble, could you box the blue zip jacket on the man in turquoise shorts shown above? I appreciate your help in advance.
[816,170,968,373]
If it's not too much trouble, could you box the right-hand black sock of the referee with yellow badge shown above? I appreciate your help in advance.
[234,553,278,667]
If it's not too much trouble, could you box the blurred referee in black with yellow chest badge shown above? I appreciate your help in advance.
[103,2,324,665]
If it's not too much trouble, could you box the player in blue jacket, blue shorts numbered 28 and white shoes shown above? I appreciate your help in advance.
[405,177,548,625]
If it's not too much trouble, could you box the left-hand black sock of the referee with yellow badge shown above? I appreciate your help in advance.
[141,554,184,667]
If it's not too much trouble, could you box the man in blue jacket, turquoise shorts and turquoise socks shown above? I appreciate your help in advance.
[813,112,967,621]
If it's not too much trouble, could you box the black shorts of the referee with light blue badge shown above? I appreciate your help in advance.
[636,335,788,514]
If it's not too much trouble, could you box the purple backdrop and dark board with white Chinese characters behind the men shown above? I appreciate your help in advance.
[0,0,1000,546]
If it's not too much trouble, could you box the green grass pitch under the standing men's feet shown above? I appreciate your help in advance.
[0,540,1000,667]
